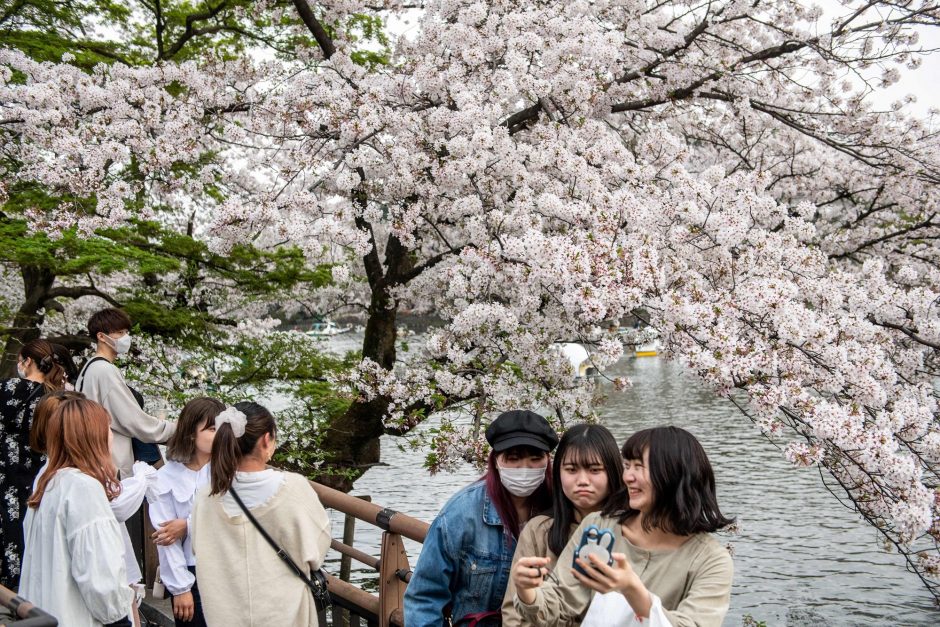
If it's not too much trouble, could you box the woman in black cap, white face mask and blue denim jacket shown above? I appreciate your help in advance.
[404,410,558,627]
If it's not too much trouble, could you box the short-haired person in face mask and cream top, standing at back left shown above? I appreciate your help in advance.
[75,308,176,478]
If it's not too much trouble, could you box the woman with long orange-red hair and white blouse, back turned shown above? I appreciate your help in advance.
[19,399,133,627]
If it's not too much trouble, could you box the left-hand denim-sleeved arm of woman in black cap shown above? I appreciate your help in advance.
[404,507,457,627]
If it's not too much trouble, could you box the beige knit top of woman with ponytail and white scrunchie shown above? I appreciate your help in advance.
[190,473,330,627]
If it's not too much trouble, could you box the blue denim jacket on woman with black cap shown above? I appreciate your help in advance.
[405,481,516,627]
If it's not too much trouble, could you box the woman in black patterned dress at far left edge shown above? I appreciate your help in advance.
[0,340,65,590]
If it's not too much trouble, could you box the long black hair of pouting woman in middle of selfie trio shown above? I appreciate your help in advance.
[548,424,624,555]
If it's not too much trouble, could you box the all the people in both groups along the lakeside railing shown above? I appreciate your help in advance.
[0,309,733,627]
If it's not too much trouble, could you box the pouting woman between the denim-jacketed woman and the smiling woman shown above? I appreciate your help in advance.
[502,424,623,627]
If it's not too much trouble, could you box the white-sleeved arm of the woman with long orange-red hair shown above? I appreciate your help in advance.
[67,512,134,624]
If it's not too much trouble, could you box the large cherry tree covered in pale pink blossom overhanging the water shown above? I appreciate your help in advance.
[0,0,940,596]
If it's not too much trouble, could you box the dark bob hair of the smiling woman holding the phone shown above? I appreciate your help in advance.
[620,427,734,536]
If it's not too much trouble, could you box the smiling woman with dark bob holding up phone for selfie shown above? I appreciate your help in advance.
[513,427,733,627]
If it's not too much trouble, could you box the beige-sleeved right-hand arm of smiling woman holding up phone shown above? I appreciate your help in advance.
[665,542,734,627]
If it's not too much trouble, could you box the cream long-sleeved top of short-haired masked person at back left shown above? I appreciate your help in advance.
[75,359,176,478]
